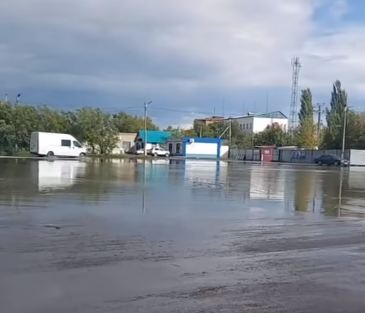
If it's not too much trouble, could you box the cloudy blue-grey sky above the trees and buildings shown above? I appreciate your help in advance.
[0,0,365,127]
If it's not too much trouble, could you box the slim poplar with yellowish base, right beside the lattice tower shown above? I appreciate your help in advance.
[296,88,317,148]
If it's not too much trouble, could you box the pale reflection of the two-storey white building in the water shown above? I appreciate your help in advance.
[250,166,285,200]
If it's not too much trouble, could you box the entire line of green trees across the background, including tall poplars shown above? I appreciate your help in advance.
[0,81,365,154]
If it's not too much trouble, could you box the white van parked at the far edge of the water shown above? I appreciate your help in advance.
[30,132,86,157]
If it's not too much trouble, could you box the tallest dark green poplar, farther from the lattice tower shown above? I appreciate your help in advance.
[323,80,347,149]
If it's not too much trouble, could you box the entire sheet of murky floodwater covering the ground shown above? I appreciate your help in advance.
[0,159,365,313]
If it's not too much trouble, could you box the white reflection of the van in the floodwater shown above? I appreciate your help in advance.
[37,160,86,191]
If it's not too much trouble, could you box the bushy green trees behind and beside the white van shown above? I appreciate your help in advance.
[0,102,158,154]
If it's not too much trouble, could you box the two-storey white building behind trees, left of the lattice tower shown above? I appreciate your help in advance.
[227,111,288,134]
